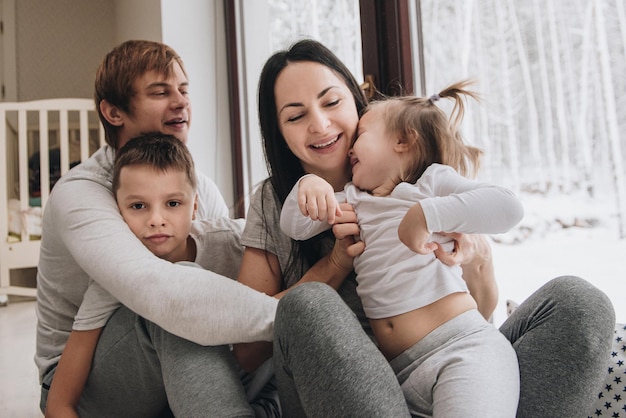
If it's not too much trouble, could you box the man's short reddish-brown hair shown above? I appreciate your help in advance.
[94,40,187,149]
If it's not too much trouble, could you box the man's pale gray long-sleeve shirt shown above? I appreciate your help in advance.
[35,146,278,375]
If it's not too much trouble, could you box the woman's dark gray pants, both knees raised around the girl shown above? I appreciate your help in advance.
[274,277,615,418]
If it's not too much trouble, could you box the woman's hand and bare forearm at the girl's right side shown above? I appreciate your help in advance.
[435,233,498,320]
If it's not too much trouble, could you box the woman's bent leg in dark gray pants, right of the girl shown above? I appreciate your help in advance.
[500,276,615,418]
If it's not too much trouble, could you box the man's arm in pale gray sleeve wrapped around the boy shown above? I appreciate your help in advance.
[42,179,277,345]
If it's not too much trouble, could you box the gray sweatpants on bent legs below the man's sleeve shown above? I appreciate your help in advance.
[41,306,254,417]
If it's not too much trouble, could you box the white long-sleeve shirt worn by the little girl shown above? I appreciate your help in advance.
[280,164,523,319]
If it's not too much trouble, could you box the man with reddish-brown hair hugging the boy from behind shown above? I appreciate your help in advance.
[35,41,277,416]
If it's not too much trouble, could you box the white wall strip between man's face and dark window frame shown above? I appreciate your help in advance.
[161,0,234,212]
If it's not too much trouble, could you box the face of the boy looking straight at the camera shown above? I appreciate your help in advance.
[116,165,197,263]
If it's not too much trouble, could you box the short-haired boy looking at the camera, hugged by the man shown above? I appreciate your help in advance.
[46,133,260,416]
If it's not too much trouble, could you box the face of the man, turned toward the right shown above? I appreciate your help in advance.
[118,62,191,149]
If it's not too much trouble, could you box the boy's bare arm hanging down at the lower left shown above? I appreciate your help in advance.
[46,328,102,417]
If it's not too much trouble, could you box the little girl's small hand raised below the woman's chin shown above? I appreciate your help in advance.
[298,175,342,225]
